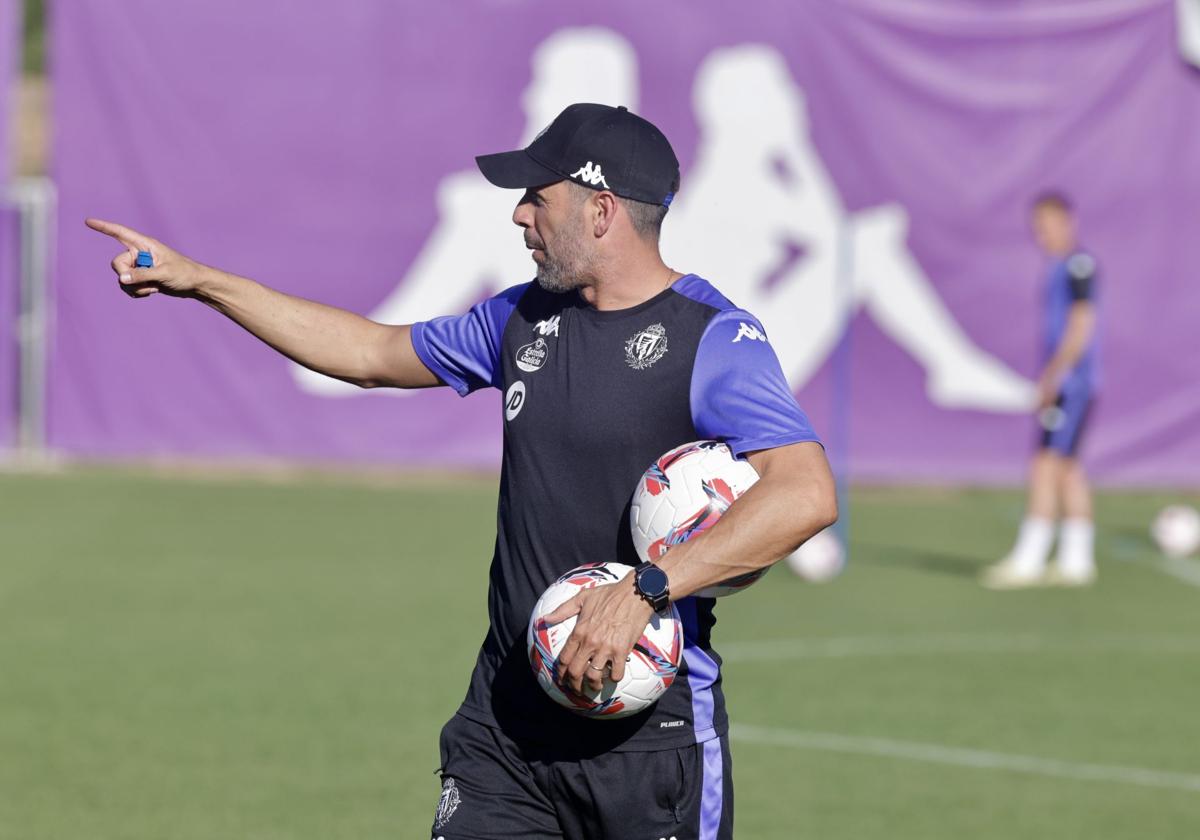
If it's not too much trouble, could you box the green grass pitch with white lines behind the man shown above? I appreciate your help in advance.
[0,470,1200,840]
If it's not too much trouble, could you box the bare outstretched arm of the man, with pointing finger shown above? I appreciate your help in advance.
[86,218,442,388]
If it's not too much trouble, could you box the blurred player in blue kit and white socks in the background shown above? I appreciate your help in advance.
[983,193,1098,589]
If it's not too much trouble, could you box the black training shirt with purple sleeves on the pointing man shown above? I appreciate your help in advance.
[413,275,817,754]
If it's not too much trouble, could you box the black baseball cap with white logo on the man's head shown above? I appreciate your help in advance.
[475,102,679,206]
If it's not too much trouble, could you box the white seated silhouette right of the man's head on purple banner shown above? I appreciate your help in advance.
[664,46,1033,412]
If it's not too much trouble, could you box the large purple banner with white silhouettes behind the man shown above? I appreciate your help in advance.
[49,0,1200,482]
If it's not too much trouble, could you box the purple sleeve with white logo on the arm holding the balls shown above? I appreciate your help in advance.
[691,310,820,457]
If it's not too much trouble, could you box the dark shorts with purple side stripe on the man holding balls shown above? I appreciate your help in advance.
[432,715,733,840]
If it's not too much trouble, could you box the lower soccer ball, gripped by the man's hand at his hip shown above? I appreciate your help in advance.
[526,563,683,720]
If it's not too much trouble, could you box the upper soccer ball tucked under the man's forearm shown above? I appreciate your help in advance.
[629,440,767,598]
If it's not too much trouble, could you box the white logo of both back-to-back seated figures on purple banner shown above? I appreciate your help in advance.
[294,33,1033,412]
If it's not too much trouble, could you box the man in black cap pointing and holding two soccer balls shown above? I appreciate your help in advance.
[88,104,836,840]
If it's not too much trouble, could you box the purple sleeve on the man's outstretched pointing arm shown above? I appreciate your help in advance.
[413,283,529,397]
